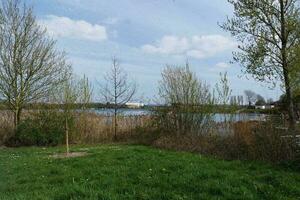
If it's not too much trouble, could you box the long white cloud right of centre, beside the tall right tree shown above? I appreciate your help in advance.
[142,35,237,59]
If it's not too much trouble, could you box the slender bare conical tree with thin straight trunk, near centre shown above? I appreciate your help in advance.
[100,58,137,140]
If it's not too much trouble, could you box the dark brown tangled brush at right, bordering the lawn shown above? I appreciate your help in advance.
[154,121,297,162]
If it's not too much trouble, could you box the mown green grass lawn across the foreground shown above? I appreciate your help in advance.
[0,145,300,200]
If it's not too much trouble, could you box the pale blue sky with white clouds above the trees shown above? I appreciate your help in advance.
[25,0,281,102]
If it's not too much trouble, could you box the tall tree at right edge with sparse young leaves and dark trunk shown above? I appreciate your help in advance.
[221,0,300,130]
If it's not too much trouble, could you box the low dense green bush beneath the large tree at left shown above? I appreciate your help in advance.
[6,110,64,146]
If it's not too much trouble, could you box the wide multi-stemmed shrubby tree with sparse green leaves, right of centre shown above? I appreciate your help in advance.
[157,63,213,134]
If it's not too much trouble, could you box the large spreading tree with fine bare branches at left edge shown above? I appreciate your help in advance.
[0,0,70,128]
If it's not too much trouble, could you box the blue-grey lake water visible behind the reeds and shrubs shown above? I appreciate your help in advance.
[90,108,267,122]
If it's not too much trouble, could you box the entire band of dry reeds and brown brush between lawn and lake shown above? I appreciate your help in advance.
[0,109,297,162]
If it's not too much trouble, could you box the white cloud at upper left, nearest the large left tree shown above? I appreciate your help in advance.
[39,15,107,42]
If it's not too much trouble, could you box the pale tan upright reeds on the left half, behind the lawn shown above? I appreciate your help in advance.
[0,111,152,146]
